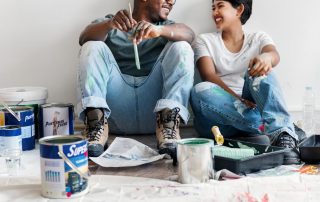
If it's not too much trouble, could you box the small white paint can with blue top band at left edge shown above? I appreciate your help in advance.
[0,125,22,151]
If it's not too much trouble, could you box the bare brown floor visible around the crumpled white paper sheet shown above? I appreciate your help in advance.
[89,126,197,179]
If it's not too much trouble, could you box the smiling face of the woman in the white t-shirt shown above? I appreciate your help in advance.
[212,0,240,30]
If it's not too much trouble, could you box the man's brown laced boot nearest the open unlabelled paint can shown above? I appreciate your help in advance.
[156,107,181,160]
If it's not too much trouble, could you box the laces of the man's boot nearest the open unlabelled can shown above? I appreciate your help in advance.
[160,107,180,139]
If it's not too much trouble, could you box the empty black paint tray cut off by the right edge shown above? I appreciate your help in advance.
[299,135,320,164]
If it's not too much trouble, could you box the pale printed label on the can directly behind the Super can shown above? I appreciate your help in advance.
[43,107,70,137]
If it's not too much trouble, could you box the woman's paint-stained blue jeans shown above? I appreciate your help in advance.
[190,72,298,142]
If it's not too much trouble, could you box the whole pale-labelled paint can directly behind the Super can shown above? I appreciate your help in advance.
[39,103,74,137]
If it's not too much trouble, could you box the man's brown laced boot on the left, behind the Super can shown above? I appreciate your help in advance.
[85,108,109,157]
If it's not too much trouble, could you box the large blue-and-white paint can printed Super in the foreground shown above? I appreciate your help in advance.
[39,135,89,198]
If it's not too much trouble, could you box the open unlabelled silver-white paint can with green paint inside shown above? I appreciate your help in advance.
[177,138,214,184]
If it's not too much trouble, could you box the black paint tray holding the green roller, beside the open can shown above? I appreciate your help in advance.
[214,139,286,174]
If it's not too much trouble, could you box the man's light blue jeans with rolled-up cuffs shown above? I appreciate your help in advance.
[77,41,194,134]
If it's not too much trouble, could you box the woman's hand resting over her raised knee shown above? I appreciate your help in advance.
[249,53,272,77]
